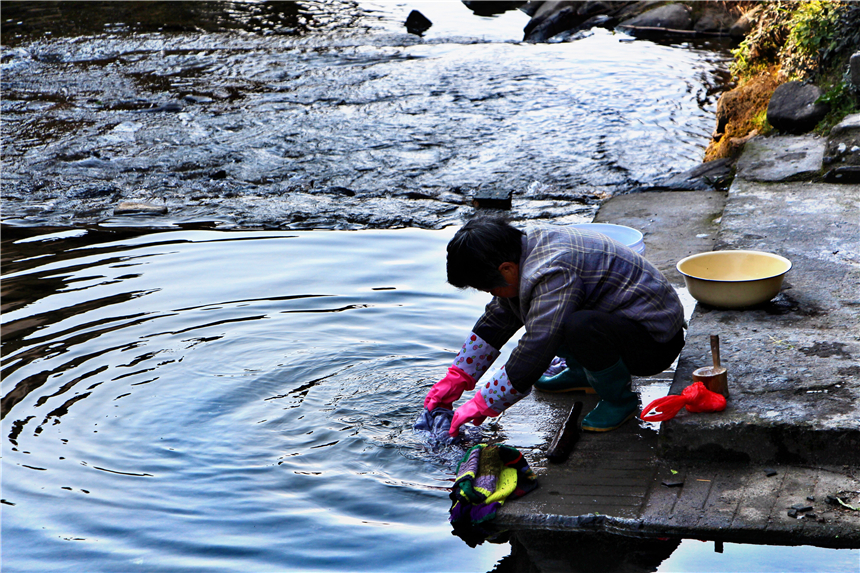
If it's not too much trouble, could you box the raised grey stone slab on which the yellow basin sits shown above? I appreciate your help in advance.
[661,179,860,464]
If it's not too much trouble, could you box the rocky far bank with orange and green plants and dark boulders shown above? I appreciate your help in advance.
[456,0,860,189]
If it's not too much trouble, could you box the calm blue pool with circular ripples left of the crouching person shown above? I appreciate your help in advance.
[2,226,507,571]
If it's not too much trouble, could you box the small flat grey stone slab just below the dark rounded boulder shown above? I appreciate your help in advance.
[737,135,826,181]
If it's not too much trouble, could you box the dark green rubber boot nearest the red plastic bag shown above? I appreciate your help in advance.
[582,360,639,432]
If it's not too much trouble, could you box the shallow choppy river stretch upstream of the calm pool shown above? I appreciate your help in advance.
[2,2,727,229]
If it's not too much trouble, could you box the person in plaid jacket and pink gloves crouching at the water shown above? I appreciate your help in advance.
[424,218,684,435]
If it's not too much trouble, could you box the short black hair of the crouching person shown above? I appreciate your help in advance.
[448,217,525,291]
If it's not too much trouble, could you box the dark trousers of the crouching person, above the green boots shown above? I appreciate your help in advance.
[564,310,684,376]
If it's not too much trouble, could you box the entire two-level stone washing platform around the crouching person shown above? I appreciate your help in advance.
[495,169,860,544]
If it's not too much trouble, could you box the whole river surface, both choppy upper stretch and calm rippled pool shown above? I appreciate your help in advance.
[0,2,857,572]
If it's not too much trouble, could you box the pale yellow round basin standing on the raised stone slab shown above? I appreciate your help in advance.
[676,251,791,308]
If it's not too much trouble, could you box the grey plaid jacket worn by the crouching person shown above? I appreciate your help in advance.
[473,226,684,389]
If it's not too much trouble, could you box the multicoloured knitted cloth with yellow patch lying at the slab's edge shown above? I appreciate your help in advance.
[449,444,537,526]
